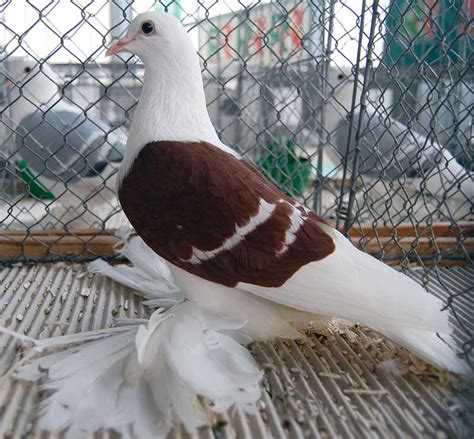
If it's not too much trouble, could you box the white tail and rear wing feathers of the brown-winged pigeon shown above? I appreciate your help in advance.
[238,225,466,372]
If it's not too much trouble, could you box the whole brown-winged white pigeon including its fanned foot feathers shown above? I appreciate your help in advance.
[0,12,468,438]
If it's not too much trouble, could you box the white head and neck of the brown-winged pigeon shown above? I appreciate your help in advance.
[106,11,220,177]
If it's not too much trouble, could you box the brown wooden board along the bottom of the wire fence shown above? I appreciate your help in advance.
[0,222,474,265]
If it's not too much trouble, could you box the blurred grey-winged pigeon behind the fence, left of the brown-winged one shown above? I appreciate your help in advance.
[4,58,126,227]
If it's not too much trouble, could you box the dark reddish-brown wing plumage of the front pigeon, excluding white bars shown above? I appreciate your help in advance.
[119,141,334,287]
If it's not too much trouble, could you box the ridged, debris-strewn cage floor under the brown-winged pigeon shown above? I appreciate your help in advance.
[0,263,474,438]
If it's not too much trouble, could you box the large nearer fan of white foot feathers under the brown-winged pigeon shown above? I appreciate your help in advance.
[0,302,262,438]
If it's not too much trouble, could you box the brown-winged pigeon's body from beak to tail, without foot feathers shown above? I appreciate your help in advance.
[107,12,467,373]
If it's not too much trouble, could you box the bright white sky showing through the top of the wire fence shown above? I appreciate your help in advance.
[0,0,388,65]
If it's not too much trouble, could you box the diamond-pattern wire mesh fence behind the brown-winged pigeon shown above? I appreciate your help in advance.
[0,0,474,358]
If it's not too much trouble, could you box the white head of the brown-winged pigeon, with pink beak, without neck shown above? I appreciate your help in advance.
[106,11,197,68]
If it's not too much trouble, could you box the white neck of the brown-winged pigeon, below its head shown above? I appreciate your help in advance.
[119,64,220,183]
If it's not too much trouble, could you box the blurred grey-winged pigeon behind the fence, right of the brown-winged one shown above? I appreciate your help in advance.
[325,70,474,204]
